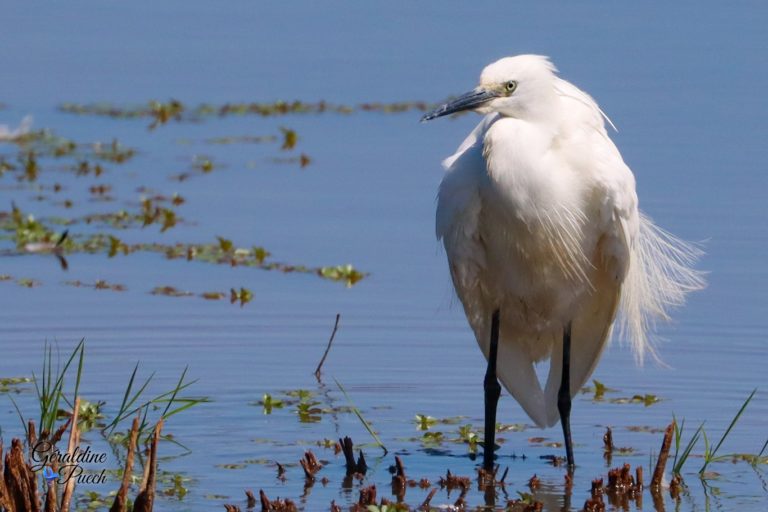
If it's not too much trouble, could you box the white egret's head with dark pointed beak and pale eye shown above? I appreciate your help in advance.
[421,55,557,121]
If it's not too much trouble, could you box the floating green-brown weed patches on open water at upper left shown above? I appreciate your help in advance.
[0,108,372,300]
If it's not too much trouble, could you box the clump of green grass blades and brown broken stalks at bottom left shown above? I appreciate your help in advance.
[0,340,208,512]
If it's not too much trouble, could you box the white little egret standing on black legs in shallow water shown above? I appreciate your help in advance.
[422,55,704,469]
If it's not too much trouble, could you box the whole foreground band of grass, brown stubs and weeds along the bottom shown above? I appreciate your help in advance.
[0,342,768,512]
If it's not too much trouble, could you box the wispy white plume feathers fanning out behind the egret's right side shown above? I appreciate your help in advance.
[618,212,706,364]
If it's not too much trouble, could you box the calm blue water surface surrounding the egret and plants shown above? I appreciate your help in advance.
[0,2,768,510]
